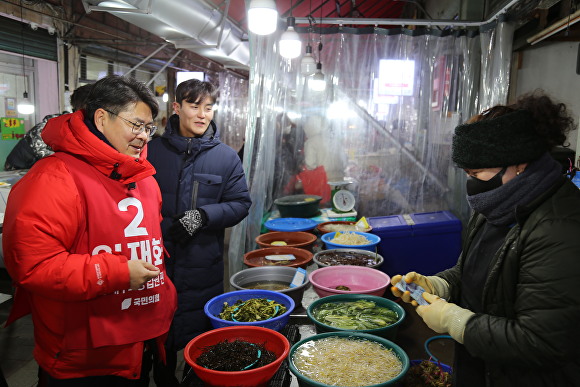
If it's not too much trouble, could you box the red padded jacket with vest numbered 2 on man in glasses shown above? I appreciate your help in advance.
[3,111,176,379]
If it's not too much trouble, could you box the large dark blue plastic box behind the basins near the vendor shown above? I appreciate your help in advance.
[368,211,461,277]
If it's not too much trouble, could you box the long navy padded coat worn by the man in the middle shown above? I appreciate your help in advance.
[147,114,252,350]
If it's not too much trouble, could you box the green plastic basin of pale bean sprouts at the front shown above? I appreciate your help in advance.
[288,332,409,387]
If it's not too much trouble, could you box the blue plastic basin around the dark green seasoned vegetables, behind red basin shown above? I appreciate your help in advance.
[203,289,295,331]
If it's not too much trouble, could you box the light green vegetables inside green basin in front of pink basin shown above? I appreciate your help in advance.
[312,300,399,330]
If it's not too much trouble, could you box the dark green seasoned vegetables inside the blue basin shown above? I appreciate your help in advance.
[217,298,287,322]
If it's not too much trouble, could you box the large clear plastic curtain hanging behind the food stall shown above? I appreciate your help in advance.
[229,23,513,273]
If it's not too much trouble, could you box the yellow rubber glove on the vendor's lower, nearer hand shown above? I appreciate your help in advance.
[416,292,475,344]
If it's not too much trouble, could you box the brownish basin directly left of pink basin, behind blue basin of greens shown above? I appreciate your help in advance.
[230,266,310,305]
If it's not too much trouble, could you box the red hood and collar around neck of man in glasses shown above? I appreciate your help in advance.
[42,110,155,184]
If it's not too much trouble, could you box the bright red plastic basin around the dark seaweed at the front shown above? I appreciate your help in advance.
[183,326,290,387]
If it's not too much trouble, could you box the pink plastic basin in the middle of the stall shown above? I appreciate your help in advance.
[308,266,391,297]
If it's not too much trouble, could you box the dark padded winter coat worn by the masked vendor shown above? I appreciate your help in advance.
[437,179,580,387]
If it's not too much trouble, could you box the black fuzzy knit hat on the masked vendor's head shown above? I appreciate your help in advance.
[451,110,549,169]
